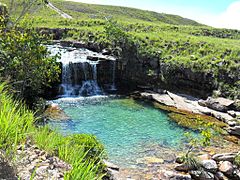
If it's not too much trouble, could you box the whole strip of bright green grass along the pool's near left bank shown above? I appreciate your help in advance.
[0,83,104,180]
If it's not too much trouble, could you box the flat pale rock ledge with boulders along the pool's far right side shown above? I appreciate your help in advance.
[136,90,240,136]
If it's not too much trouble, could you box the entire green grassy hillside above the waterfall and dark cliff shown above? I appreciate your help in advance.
[3,0,240,98]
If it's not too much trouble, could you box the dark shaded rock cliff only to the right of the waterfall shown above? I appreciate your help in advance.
[117,45,216,96]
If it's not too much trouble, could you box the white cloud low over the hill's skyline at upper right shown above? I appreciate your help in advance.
[66,0,240,29]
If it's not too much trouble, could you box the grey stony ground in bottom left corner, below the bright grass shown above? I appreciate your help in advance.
[0,141,72,180]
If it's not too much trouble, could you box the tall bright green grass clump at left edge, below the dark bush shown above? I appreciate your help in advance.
[0,83,34,155]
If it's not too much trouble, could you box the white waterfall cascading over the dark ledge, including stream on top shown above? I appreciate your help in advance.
[48,45,116,97]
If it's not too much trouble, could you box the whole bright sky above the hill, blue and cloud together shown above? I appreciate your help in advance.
[65,0,240,29]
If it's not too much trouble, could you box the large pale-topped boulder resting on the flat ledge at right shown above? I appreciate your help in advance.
[202,97,234,112]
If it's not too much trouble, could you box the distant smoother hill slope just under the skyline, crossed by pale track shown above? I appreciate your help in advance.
[2,0,204,26]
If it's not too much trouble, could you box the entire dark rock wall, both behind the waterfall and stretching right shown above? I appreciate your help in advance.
[47,41,238,98]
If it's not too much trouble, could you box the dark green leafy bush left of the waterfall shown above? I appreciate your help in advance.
[0,15,60,102]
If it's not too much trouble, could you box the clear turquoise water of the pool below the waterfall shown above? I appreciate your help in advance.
[50,97,197,166]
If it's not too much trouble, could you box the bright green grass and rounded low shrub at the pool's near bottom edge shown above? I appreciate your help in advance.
[33,127,105,180]
